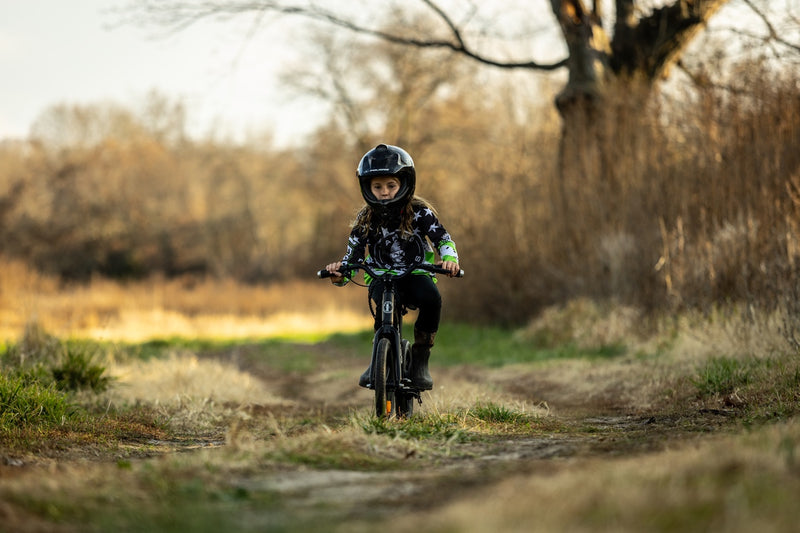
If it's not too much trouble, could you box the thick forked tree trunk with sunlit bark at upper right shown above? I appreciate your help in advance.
[550,0,728,234]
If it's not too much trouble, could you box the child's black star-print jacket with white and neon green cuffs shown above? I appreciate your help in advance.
[342,205,458,285]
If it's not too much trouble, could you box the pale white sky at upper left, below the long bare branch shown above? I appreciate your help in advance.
[0,0,316,145]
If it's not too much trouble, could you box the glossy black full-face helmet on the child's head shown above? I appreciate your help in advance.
[356,144,417,217]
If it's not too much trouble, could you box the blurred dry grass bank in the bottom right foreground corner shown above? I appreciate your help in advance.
[398,422,800,532]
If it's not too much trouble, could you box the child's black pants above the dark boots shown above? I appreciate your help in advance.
[369,274,442,333]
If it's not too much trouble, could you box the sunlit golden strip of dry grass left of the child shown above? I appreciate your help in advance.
[0,260,370,342]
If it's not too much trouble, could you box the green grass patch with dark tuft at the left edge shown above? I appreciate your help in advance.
[0,325,174,455]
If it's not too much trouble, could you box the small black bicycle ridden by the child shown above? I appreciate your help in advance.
[317,263,464,418]
